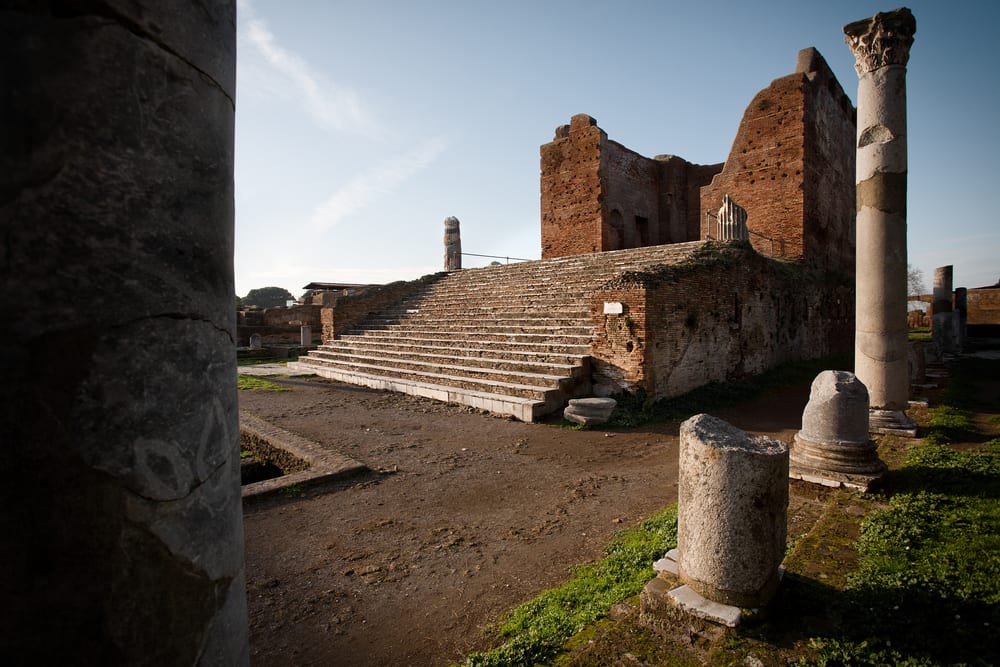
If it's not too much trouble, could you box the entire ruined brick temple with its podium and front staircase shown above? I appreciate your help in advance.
[296,49,855,421]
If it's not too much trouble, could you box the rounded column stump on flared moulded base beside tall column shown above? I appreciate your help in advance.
[788,371,886,491]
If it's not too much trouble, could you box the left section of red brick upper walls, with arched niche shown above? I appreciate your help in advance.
[541,114,722,259]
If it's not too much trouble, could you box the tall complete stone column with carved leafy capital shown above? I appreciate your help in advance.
[844,8,916,435]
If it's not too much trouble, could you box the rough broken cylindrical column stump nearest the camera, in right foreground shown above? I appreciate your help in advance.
[677,414,788,607]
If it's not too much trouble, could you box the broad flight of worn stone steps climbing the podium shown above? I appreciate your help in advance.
[288,242,702,422]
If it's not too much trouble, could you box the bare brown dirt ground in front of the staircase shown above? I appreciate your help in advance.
[240,379,820,666]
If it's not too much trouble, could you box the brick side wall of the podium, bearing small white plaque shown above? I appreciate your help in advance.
[591,243,854,399]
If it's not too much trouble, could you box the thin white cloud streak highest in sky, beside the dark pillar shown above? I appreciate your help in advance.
[239,0,375,134]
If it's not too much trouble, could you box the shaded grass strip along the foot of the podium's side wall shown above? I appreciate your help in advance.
[608,354,854,428]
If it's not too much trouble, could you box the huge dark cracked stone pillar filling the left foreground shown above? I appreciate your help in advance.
[0,0,248,665]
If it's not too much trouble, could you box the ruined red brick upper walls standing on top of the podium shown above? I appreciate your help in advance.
[541,48,856,273]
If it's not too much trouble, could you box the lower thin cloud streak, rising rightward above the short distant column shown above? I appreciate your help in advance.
[312,137,447,231]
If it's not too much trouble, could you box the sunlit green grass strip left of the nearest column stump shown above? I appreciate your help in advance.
[465,506,677,667]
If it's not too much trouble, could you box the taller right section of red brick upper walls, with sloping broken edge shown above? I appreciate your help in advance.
[701,49,856,273]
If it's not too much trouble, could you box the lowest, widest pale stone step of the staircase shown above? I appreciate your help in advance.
[288,362,558,422]
